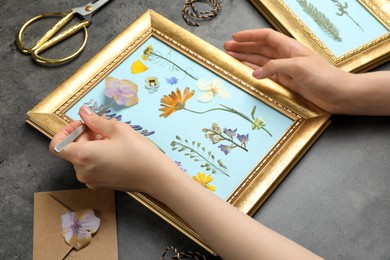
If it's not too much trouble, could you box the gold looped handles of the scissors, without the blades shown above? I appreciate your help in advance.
[16,11,89,65]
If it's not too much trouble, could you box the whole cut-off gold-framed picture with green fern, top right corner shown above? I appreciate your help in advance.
[249,0,390,72]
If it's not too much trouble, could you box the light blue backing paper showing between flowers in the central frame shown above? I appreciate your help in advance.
[66,37,293,199]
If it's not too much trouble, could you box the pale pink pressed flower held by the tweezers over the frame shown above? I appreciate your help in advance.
[104,77,138,107]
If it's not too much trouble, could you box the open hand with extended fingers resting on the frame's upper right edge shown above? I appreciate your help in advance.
[224,29,351,113]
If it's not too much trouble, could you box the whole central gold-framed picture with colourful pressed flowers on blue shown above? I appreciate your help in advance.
[27,10,330,253]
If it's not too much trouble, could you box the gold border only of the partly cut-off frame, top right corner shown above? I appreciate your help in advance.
[249,0,390,72]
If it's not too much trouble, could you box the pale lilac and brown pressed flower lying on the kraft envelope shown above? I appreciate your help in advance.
[61,209,100,250]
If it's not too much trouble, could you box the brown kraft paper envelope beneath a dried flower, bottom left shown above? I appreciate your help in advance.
[33,189,118,260]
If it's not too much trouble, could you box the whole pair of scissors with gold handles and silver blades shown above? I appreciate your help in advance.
[16,0,111,65]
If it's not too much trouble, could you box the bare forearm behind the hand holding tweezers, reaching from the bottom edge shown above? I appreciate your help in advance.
[149,161,318,259]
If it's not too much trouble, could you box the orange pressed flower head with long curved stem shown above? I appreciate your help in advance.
[159,87,195,117]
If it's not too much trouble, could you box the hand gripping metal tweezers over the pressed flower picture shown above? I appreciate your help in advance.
[49,106,174,193]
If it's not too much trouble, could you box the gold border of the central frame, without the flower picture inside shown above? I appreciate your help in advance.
[27,10,330,254]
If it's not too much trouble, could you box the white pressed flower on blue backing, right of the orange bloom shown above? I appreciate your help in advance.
[196,78,230,103]
